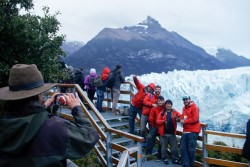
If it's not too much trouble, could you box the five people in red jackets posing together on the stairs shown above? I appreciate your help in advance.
[129,76,200,166]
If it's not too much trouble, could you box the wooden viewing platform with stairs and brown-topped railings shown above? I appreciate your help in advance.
[48,82,248,167]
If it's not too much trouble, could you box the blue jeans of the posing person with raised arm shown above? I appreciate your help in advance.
[129,104,142,134]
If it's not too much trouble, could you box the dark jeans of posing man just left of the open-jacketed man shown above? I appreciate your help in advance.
[146,126,158,154]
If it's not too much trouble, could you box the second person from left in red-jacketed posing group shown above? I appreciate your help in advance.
[140,86,161,138]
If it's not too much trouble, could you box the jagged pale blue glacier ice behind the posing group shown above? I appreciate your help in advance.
[127,67,250,134]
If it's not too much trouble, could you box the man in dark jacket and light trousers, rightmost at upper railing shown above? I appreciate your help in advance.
[111,65,125,115]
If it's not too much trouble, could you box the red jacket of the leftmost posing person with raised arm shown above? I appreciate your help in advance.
[132,77,147,108]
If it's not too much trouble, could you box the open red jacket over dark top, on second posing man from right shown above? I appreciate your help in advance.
[156,110,181,136]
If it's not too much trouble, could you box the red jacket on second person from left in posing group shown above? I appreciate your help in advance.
[142,93,157,115]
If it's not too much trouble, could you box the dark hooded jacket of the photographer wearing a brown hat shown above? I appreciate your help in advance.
[0,105,99,167]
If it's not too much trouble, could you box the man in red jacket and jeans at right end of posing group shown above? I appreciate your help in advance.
[180,95,201,166]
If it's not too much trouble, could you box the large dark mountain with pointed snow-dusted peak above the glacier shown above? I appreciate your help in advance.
[65,17,228,75]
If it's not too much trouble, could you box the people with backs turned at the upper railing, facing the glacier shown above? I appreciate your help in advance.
[64,65,125,115]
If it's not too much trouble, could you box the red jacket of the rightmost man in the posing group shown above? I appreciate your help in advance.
[181,102,201,133]
